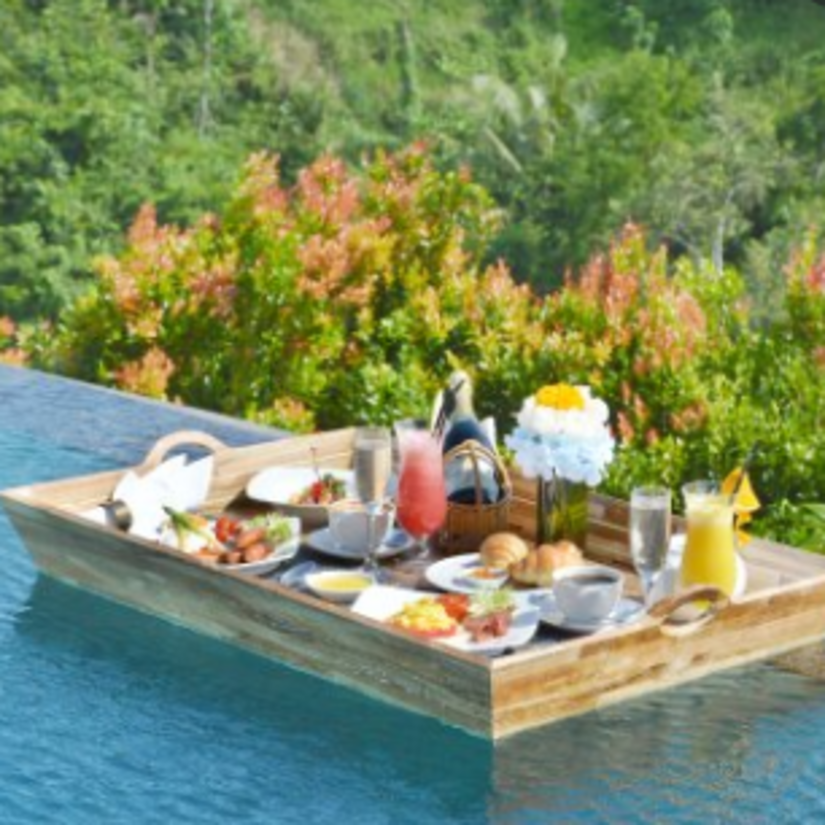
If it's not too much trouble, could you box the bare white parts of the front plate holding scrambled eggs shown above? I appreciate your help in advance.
[352,584,541,656]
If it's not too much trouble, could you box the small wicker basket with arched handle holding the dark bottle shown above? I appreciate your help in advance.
[437,441,513,555]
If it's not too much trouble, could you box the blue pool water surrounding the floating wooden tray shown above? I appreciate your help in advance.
[0,368,825,825]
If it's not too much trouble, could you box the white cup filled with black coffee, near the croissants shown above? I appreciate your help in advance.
[553,564,624,624]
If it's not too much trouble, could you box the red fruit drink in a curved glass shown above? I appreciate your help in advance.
[396,431,447,538]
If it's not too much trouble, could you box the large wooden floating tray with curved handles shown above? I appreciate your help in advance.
[0,430,825,739]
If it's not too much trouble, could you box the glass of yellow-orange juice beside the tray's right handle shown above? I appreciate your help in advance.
[682,481,736,596]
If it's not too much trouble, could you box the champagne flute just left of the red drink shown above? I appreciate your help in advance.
[354,427,392,581]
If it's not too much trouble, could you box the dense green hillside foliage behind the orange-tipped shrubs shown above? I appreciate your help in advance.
[8,0,825,318]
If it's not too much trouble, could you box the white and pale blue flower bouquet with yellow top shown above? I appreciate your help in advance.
[505,384,615,487]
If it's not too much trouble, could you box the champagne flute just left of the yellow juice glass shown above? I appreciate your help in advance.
[630,486,670,604]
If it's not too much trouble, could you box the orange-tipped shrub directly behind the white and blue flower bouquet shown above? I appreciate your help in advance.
[520,225,709,487]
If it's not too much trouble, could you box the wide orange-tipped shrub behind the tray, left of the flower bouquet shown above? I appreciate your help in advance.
[46,146,539,429]
